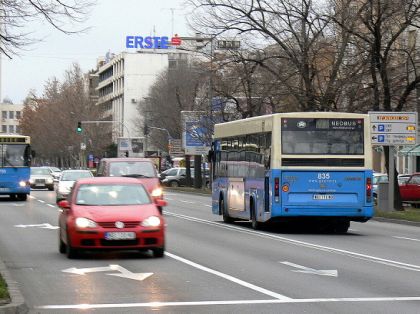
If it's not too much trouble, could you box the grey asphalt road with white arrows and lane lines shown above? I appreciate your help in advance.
[0,190,420,314]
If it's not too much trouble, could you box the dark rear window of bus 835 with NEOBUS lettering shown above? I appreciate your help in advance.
[281,118,364,155]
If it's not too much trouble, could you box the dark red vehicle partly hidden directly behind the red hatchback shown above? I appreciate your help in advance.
[96,157,163,202]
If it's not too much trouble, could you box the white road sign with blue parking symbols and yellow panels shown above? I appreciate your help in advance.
[369,111,417,146]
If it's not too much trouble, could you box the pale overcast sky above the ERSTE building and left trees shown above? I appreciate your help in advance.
[1,0,191,104]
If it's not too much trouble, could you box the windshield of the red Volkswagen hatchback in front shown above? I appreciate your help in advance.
[76,184,151,206]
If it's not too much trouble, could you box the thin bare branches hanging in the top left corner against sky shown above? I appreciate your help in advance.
[0,0,94,58]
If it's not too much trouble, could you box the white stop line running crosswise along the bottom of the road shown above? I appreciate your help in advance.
[35,297,420,310]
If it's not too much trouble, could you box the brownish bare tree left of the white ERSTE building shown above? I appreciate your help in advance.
[20,64,111,166]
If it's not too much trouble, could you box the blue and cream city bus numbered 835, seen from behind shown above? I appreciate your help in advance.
[209,112,373,233]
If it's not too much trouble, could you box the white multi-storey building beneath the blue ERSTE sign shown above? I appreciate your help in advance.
[96,49,193,142]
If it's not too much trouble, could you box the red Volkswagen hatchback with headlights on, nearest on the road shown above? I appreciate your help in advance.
[58,177,167,258]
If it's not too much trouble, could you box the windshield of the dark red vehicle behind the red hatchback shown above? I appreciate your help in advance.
[109,161,156,177]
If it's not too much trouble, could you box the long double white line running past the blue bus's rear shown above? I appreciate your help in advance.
[165,212,420,272]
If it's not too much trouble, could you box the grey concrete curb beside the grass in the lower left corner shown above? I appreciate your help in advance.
[0,260,29,314]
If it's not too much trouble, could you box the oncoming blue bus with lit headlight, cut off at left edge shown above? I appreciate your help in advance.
[0,134,31,201]
